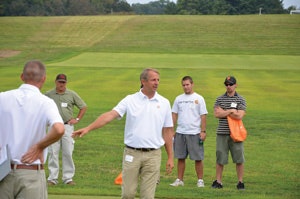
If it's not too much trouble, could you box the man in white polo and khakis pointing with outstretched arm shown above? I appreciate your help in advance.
[73,68,174,199]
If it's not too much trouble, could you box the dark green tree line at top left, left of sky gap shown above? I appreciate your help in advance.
[0,0,131,16]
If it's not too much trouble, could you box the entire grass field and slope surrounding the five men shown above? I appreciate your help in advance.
[0,15,300,199]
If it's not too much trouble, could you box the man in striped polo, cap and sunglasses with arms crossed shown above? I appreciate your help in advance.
[211,76,246,190]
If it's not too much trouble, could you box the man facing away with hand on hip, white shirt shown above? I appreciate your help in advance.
[0,61,64,199]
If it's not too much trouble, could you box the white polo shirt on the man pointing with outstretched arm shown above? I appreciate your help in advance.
[113,90,173,149]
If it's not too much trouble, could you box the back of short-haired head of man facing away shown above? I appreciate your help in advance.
[23,60,46,82]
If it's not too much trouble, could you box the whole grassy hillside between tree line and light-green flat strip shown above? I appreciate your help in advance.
[0,15,300,66]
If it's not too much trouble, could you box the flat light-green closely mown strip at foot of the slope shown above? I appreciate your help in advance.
[49,52,300,70]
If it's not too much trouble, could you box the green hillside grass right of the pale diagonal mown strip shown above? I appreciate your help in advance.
[94,15,300,55]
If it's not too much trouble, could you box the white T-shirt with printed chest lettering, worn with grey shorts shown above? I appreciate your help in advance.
[172,93,208,135]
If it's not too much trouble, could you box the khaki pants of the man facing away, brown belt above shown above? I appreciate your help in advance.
[0,169,48,199]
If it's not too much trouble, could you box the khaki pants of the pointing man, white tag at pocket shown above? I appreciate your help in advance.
[122,148,161,199]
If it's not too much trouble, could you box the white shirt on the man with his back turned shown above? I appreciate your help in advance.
[0,84,63,164]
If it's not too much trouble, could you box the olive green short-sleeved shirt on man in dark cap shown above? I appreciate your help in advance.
[45,88,86,123]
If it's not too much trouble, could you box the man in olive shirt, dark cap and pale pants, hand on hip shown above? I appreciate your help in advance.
[45,74,87,185]
